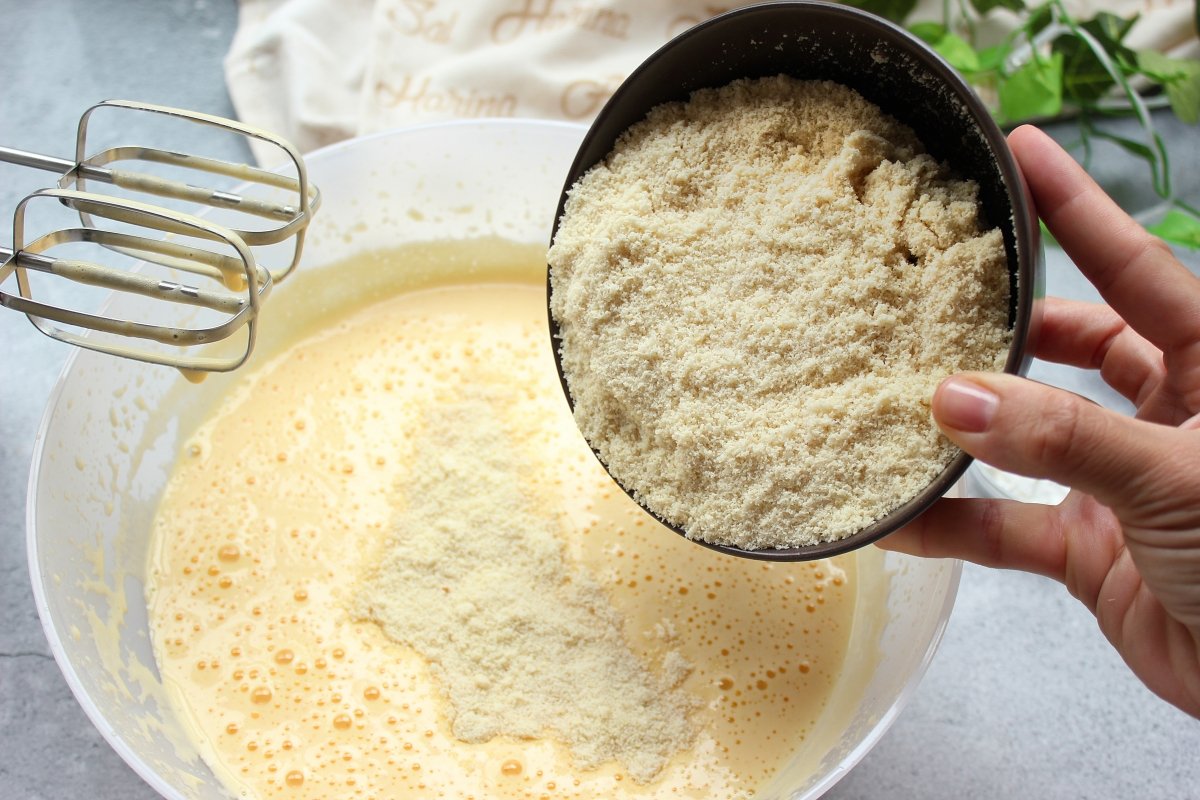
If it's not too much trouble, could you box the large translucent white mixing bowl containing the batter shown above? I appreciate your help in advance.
[28,120,960,800]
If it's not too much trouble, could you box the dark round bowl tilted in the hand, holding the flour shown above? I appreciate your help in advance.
[547,0,1044,561]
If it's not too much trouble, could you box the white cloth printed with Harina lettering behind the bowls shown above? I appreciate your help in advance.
[226,0,1200,163]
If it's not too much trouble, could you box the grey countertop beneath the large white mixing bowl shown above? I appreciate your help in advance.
[0,0,1200,800]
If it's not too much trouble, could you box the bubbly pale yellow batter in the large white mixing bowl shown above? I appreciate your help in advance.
[149,241,857,800]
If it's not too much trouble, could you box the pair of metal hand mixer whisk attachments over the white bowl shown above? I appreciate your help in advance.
[0,101,320,372]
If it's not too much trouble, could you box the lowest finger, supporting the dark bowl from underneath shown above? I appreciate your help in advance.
[877,498,1067,581]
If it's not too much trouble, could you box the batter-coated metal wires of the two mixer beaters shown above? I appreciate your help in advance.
[0,101,320,372]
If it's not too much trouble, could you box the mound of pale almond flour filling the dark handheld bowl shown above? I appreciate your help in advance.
[548,77,1010,549]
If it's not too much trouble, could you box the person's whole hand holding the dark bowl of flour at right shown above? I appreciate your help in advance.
[880,127,1200,716]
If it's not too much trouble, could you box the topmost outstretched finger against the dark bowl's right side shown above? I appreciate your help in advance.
[1008,126,1200,357]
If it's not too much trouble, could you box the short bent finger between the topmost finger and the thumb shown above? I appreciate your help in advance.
[1037,297,1165,410]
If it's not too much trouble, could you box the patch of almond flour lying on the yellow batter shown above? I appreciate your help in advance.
[355,389,695,783]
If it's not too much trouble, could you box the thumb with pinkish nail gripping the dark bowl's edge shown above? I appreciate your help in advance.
[932,373,1196,518]
